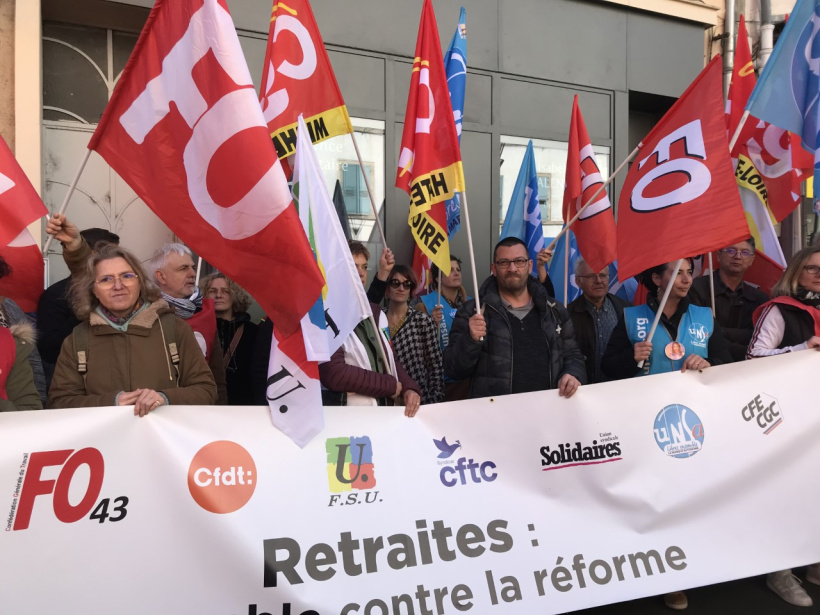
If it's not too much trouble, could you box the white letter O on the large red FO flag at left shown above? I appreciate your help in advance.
[183,88,291,240]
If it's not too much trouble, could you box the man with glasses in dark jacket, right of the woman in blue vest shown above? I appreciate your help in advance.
[689,237,769,361]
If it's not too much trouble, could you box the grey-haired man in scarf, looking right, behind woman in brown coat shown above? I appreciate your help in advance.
[146,243,228,405]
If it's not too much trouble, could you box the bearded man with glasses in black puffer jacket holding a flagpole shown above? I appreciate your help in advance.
[444,237,586,398]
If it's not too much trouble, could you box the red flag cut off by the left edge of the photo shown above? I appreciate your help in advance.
[0,138,48,312]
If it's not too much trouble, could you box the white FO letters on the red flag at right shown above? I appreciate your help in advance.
[630,120,712,213]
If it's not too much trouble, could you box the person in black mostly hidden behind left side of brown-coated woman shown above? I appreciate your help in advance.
[37,217,120,385]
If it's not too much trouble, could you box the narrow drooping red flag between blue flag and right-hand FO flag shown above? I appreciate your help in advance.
[564,94,617,271]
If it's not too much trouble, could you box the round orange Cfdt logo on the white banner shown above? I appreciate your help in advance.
[188,440,257,514]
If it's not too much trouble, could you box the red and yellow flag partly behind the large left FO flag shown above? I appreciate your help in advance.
[259,0,353,159]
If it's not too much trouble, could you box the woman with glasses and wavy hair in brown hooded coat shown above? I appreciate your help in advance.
[48,244,216,416]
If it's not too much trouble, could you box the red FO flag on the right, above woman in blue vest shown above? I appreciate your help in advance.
[618,56,749,279]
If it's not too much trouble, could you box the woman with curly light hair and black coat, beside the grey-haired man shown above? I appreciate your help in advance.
[199,273,259,406]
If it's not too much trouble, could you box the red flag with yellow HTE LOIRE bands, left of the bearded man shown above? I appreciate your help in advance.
[396,0,464,275]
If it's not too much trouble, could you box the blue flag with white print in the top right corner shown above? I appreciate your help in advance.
[746,0,820,198]
